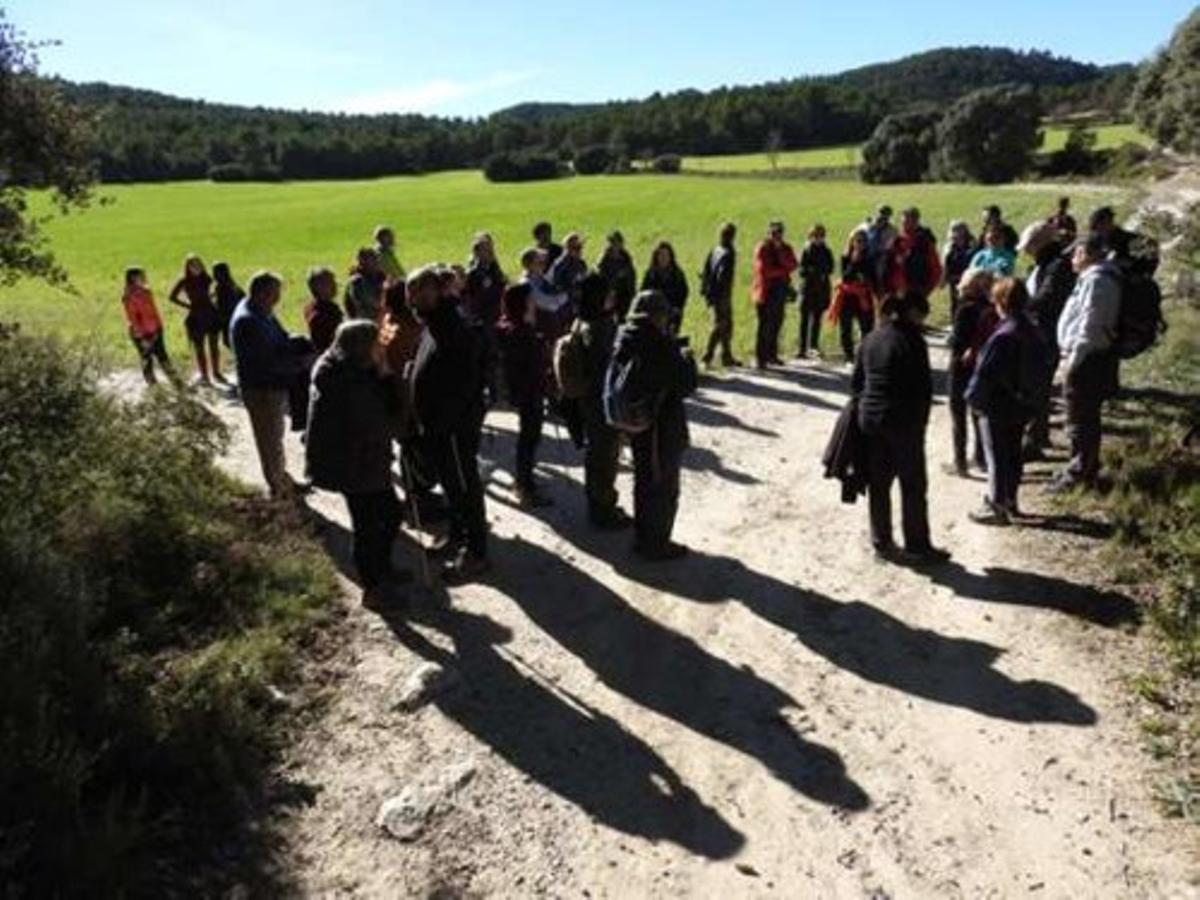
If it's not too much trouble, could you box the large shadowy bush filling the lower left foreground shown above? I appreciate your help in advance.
[0,335,335,896]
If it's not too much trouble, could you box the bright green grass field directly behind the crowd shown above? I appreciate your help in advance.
[0,172,1121,365]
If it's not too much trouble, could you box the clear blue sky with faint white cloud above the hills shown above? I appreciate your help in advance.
[7,0,1193,115]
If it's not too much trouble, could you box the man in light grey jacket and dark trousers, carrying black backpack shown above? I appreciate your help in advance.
[1051,234,1121,492]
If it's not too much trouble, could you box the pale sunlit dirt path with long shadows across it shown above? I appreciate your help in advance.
[211,340,1198,899]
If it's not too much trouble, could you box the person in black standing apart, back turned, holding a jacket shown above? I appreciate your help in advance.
[851,293,949,564]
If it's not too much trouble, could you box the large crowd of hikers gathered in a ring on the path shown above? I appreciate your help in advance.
[124,196,1152,601]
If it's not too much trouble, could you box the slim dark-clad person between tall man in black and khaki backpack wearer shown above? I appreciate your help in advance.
[497,283,552,509]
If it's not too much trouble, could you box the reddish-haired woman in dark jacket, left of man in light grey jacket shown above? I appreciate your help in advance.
[966,278,1046,526]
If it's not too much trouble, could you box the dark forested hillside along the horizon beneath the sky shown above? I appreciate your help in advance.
[62,47,1133,181]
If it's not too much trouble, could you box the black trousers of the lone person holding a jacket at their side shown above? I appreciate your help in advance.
[864,425,930,552]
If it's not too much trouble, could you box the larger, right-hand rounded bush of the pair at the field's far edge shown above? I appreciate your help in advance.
[930,85,1042,185]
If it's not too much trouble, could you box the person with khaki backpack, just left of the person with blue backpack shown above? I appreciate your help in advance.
[574,275,632,530]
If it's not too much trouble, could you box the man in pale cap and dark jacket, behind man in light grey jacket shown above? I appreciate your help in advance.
[1021,223,1075,461]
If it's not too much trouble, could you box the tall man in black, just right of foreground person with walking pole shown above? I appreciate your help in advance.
[408,266,490,583]
